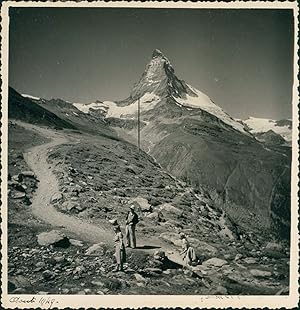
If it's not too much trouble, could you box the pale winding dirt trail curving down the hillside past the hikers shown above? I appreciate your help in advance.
[18,121,182,264]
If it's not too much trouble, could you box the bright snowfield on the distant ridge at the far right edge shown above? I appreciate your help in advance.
[243,117,292,142]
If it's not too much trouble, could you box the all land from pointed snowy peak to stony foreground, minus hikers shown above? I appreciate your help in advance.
[8,50,291,295]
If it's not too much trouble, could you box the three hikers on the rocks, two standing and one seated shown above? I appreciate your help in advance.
[110,205,197,272]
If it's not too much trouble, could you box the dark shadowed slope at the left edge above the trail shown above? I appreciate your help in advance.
[8,87,76,129]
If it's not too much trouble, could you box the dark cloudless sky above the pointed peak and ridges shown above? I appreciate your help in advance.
[9,8,294,119]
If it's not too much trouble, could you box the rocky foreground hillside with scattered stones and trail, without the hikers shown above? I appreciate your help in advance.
[8,121,289,295]
